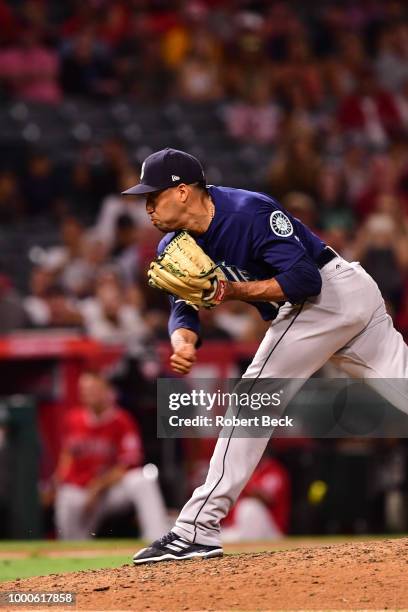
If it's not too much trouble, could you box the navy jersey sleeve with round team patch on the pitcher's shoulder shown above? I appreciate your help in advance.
[253,207,322,304]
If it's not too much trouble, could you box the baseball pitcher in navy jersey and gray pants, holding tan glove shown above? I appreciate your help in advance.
[124,149,408,564]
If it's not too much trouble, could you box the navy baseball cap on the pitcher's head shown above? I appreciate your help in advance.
[122,148,205,195]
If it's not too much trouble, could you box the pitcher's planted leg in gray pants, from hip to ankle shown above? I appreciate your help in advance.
[173,258,372,545]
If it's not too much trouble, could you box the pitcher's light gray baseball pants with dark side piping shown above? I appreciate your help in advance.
[173,257,408,545]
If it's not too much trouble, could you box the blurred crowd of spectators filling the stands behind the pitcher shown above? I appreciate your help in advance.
[0,0,408,344]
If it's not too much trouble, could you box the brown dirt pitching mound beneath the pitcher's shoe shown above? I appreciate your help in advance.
[1,538,408,611]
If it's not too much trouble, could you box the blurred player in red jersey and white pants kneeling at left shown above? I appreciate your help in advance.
[55,373,168,540]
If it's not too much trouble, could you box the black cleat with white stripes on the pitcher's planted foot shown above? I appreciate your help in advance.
[133,531,223,565]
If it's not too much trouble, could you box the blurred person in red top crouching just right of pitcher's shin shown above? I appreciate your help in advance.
[222,457,290,542]
